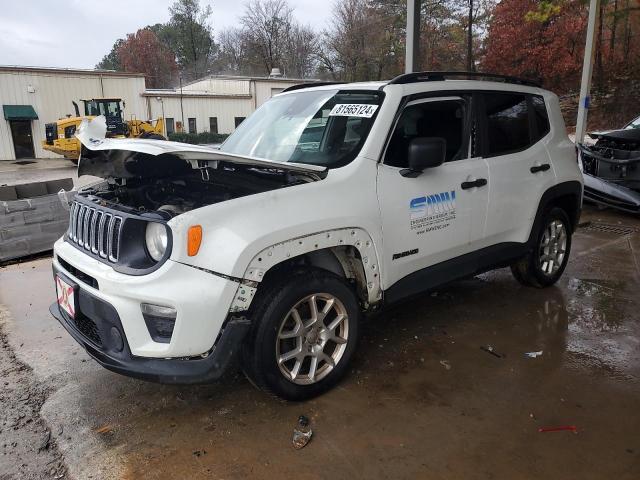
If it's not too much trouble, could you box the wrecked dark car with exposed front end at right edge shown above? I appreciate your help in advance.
[578,129,640,213]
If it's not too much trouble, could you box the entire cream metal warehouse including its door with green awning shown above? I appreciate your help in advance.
[0,66,308,160]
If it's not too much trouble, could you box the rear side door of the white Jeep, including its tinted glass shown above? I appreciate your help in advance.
[479,92,555,246]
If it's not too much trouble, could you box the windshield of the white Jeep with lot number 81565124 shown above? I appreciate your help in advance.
[220,90,382,168]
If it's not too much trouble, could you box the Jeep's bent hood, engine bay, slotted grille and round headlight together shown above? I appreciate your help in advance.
[65,117,326,275]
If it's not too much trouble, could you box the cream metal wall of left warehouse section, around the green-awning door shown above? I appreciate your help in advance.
[0,71,147,160]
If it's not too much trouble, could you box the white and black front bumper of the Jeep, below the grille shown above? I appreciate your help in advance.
[50,240,248,383]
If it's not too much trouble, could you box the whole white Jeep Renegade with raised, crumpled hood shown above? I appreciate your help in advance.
[51,72,582,400]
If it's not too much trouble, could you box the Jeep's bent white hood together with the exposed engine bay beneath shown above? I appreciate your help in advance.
[77,117,326,218]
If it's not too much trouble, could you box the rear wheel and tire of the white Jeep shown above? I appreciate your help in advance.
[511,207,571,288]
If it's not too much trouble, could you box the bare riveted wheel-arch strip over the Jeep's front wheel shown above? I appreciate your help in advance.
[230,227,382,313]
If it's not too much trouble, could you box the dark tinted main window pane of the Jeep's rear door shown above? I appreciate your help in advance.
[483,93,531,157]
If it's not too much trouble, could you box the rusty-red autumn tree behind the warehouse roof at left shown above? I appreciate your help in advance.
[118,28,178,88]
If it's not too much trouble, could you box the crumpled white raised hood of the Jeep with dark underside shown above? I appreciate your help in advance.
[76,115,326,178]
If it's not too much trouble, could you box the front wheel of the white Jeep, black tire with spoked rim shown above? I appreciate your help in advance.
[242,269,360,401]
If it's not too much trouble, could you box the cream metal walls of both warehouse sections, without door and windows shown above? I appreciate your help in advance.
[0,68,310,160]
